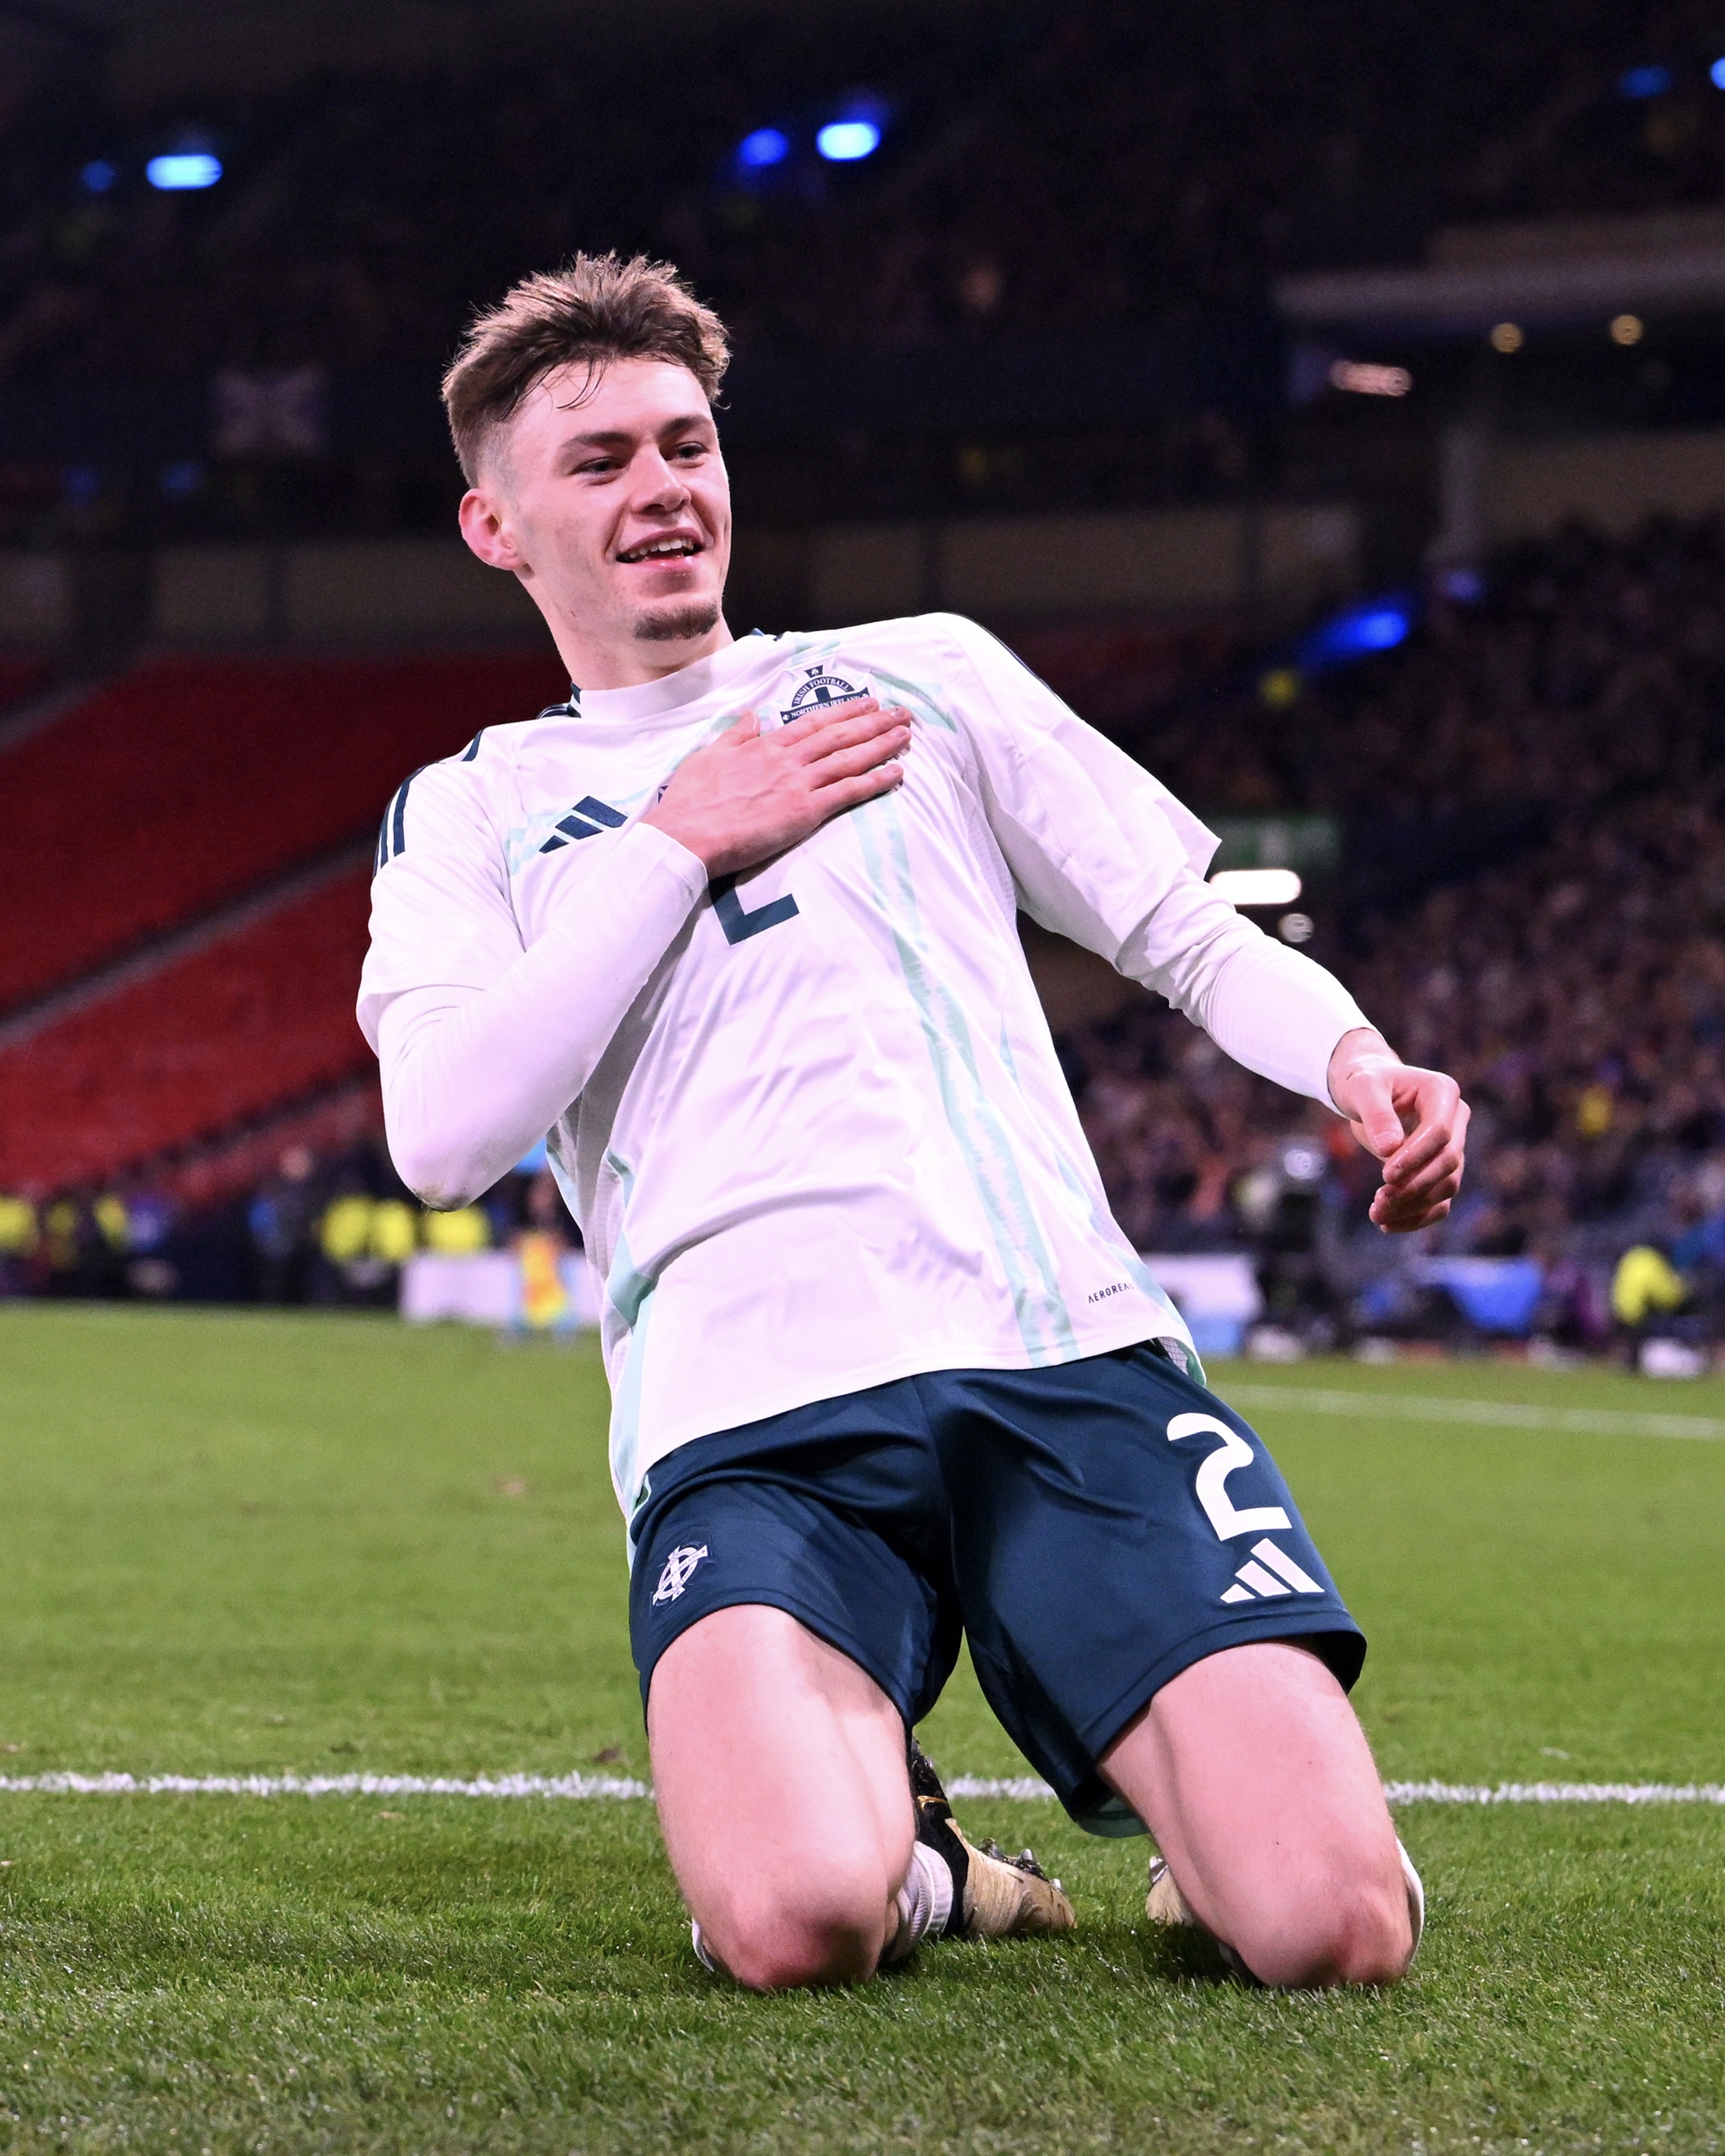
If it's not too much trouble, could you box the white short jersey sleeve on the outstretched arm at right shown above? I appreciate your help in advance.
[936,615,1219,966]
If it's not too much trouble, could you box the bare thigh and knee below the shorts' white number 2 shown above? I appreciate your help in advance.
[1101,1641,1412,1985]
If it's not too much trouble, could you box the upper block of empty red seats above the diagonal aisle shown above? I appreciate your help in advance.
[0,654,565,1013]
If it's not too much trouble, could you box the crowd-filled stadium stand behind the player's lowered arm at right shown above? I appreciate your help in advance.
[1063,522,1725,1341]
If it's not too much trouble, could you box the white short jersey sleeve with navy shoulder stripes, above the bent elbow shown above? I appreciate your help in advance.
[358,763,522,1050]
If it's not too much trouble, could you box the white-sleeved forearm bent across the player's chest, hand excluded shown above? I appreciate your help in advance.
[377,832,707,1207]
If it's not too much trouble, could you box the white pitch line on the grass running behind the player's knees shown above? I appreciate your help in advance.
[0,1775,1725,1805]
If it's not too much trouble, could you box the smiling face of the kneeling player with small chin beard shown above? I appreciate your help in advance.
[462,360,731,688]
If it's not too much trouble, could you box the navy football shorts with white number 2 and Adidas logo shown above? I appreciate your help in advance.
[630,1345,1365,1832]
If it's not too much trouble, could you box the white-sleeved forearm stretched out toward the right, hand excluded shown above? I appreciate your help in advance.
[1119,877,1369,1108]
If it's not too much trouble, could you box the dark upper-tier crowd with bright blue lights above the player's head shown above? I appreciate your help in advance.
[0,0,1725,388]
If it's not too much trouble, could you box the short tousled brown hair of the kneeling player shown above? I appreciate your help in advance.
[444,254,731,485]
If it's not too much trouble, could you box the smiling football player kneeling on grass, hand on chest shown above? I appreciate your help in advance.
[360,257,1466,1988]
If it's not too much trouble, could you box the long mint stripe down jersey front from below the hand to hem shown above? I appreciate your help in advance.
[852,796,1078,1363]
